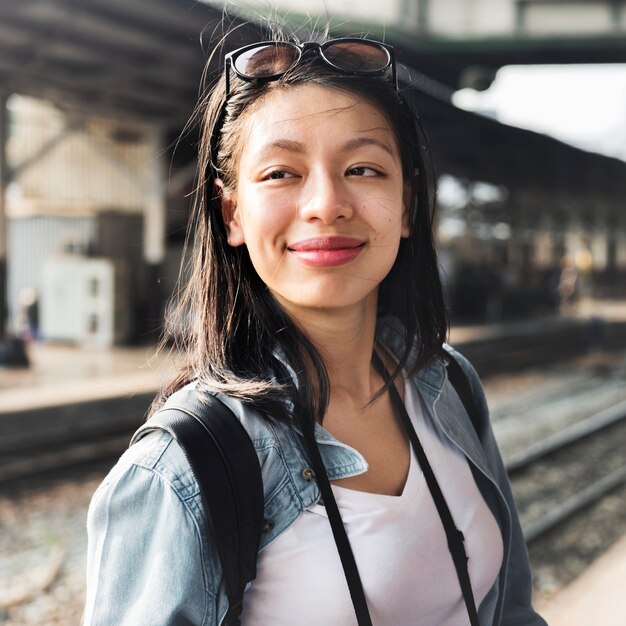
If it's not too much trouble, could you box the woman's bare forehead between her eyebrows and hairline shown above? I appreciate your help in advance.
[243,84,397,152]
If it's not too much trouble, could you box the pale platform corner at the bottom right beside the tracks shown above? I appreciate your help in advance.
[536,536,626,626]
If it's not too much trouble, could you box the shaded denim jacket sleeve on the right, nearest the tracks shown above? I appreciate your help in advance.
[444,351,546,626]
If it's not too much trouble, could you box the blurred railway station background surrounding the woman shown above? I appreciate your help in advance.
[0,0,626,626]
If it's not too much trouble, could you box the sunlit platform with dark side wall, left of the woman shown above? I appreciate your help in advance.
[0,342,177,476]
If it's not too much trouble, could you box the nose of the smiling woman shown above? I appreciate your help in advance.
[299,171,353,224]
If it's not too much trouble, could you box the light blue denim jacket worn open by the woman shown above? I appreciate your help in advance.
[83,322,545,626]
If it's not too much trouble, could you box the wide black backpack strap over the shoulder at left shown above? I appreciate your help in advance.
[131,388,264,625]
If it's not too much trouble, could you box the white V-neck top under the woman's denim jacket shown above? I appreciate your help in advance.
[241,376,503,626]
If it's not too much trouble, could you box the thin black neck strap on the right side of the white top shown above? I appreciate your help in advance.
[372,353,480,626]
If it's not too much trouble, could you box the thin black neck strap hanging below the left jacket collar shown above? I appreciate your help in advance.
[303,420,372,626]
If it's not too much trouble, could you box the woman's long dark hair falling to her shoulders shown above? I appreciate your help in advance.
[156,31,448,423]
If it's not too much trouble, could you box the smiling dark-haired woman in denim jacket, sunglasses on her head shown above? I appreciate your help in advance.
[85,30,544,626]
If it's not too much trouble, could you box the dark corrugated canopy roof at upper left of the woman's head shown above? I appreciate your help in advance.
[0,0,252,127]
